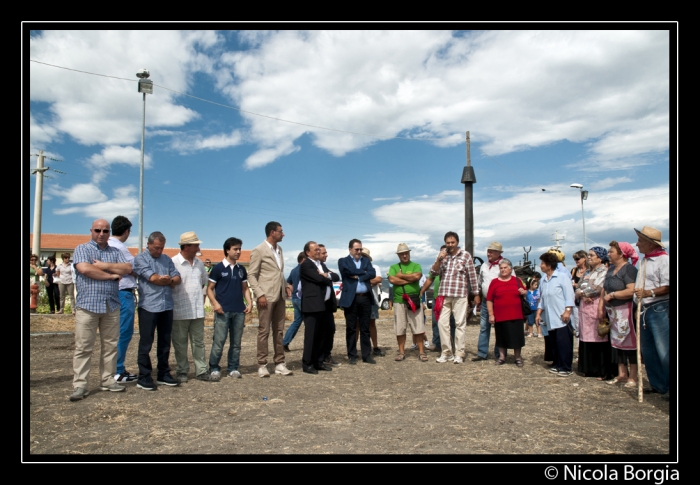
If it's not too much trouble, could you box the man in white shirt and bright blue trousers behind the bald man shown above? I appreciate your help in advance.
[107,216,138,384]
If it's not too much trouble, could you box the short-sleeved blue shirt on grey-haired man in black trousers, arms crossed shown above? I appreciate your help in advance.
[133,249,180,313]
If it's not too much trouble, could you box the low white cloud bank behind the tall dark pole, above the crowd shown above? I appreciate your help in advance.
[370,183,670,259]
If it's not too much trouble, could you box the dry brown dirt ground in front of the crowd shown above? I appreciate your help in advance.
[22,311,676,461]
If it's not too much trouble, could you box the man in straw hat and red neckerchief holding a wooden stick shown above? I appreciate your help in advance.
[634,226,671,395]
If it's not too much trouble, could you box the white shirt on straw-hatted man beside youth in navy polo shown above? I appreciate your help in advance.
[173,253,209,320]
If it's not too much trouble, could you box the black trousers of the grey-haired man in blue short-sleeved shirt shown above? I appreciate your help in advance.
[138,308,173,382]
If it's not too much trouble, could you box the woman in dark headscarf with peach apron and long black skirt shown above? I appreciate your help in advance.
[576,246,614,381]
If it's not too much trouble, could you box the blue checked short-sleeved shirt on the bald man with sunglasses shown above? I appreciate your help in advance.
[73,241,127,313]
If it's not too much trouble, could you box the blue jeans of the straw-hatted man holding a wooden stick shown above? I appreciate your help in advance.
[640,300,670,394]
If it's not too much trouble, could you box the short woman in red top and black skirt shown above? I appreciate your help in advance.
[486,259,527,367]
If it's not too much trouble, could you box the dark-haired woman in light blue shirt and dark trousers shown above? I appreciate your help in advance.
[535,252,574,377]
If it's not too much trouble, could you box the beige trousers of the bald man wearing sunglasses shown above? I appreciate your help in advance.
[73,305,119,388]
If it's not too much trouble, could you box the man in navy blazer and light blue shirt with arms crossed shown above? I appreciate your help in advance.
[338,239,377,365]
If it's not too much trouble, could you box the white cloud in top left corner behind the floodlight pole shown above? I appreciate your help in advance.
[29,30,218,145]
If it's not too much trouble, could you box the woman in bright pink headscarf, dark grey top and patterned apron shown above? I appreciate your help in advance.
[598,241,639,387]
